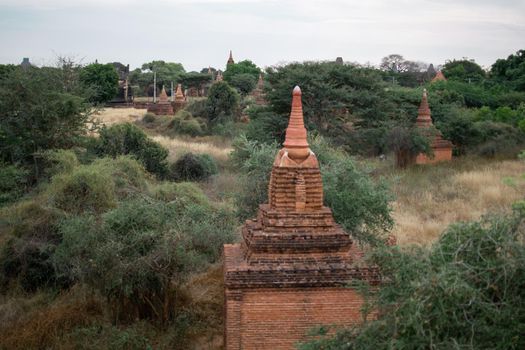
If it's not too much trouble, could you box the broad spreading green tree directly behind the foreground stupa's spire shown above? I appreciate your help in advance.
[266,62,389,142]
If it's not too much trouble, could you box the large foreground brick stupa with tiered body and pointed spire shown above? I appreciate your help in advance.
[224,87,379,350]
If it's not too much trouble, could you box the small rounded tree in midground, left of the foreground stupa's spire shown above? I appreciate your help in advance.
[206,81,239,122]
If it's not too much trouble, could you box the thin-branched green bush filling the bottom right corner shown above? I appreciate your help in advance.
[300,213,525,350]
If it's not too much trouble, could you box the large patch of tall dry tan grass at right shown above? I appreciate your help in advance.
[391,159,525,245]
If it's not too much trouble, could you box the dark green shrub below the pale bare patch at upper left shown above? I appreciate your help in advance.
[97,123,168,177]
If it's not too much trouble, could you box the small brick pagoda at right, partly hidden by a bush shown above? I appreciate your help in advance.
[416,89,452,164]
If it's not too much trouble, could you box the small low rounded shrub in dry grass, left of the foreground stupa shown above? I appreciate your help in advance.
[171,153,217,181]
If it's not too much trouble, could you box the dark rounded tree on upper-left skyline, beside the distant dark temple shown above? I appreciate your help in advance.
[80,63,118,103]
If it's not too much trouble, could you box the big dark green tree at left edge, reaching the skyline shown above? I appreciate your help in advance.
[0,67,91,169]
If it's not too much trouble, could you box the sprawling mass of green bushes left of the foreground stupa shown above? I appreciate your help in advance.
[0,151,236,322]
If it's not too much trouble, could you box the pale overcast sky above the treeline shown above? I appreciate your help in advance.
[0,0,525,71]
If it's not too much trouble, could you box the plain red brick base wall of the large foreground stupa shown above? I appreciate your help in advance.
[225,287,362,350]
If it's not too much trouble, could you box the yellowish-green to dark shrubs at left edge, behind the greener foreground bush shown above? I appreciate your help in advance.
[0,156,147,291]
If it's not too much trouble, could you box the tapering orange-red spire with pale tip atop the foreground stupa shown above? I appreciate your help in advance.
[283,86,310,160]
